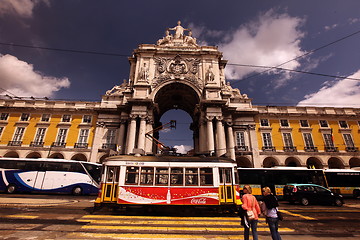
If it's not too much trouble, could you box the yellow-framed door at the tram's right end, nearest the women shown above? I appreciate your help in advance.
[219,168,236,204]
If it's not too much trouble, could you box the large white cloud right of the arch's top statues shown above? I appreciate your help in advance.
[219,10,304,86]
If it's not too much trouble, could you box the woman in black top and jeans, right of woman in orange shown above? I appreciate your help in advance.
[261,187,281,240]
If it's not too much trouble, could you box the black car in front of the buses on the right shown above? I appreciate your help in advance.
[284,184,344,207]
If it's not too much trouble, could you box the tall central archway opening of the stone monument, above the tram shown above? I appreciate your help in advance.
[154,82,200,154]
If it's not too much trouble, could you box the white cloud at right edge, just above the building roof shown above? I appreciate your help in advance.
[298,70,360,107]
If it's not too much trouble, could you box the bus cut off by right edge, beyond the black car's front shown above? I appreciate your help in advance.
[325,169,360,198]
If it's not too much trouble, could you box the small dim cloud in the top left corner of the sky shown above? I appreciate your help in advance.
[0,0,50,18]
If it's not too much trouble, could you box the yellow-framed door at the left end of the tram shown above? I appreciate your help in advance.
[103,166,120,202]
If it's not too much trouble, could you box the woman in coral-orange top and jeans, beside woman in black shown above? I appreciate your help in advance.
[241,185,261,240]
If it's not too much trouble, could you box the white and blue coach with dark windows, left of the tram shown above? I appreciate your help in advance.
[0,158,101,195]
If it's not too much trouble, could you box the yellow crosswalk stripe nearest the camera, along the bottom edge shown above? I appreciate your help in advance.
[68,233,244,240]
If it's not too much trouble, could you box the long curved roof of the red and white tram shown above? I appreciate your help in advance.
[105,155,236,163]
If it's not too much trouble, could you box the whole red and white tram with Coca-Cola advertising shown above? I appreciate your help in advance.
[94,156,241,211]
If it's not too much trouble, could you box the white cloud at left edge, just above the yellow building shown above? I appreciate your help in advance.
[0,54,70,97]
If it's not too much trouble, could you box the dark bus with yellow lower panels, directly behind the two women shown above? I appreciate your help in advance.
[238,167,327,199]
